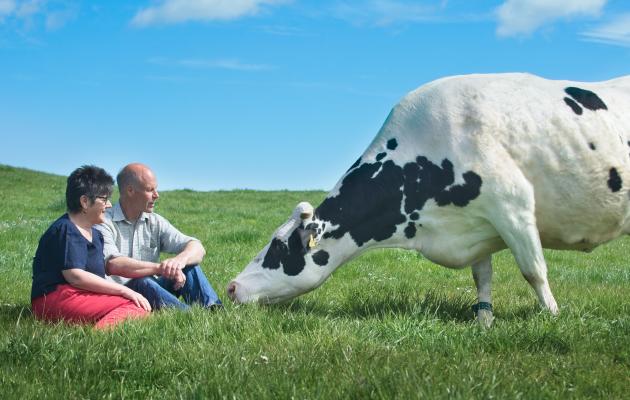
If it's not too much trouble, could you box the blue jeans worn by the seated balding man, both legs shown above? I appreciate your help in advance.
[127,265,222,310]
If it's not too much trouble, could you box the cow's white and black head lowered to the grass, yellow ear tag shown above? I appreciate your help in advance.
[227,202,330,303]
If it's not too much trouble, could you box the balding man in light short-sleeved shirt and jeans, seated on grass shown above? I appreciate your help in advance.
[98,163,221,309]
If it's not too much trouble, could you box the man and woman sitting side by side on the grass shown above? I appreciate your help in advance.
[31,164,221,328]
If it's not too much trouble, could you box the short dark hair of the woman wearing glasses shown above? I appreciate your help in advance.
[66,165,114,213]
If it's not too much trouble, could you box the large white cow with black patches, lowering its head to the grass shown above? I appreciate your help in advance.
[227,74,630,324]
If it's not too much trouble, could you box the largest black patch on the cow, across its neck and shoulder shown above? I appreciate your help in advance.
[315,156,482,246]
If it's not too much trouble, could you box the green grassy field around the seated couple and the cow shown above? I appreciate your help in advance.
[0,166,630,399]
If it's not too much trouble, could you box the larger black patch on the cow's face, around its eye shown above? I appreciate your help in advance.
[262,229,306,276]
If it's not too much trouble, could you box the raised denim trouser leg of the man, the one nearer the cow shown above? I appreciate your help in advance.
[158,265,222,307]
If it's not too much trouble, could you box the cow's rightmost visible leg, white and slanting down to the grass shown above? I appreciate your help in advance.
[493,206,558,315]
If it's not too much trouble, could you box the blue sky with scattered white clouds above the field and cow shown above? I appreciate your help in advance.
[0,0,630,190]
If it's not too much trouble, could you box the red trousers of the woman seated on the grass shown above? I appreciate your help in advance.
[31,285,149,329]
